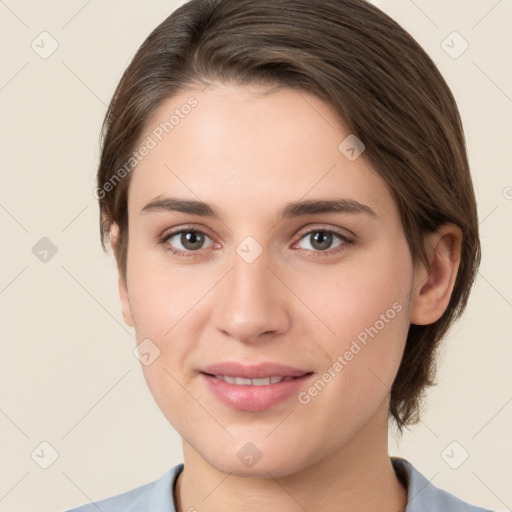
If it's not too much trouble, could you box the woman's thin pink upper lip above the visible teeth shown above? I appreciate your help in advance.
[200,361,312,379]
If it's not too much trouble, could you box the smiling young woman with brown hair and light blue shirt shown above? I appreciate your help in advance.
[66,0,494,512]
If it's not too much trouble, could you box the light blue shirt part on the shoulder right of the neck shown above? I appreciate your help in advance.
[391,457,491,512]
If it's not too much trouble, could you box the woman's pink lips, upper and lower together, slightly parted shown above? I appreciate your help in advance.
[200,362,314,412]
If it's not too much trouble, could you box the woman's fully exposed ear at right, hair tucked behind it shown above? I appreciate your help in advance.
[410,223,462,325]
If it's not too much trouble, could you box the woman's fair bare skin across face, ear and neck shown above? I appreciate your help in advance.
[111,83,460,512]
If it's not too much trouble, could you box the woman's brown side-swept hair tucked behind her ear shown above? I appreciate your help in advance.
[96,0,480,432]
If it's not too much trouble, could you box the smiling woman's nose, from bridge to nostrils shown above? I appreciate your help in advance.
[214,251,291,343]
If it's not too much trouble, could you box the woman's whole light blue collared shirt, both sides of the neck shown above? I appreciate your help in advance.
[67,457,491,512]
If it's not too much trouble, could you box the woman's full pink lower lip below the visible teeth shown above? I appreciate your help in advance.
[201,373,313,412]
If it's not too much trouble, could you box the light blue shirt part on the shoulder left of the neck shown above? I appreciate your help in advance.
[66,464,183,512]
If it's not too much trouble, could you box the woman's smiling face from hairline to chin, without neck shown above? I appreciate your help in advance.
[120,83,414,476]
